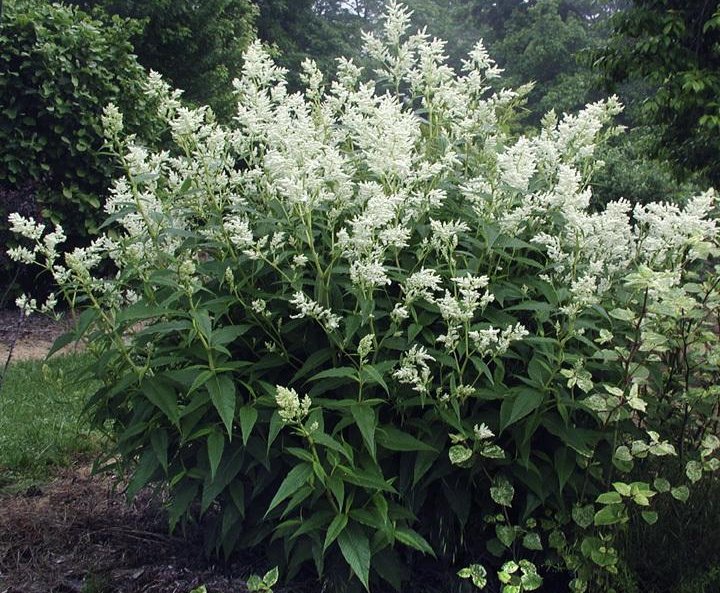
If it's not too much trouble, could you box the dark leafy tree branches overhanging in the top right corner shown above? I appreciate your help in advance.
[595,0,720,183]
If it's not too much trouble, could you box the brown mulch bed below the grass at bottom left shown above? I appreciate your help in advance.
[0,463,265,593]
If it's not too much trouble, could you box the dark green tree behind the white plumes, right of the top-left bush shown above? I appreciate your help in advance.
[70,0,258,120]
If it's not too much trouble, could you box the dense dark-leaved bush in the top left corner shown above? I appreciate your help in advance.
[0,0,162,241]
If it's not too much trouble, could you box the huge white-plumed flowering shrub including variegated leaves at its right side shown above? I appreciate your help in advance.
[11,4,720,593]
